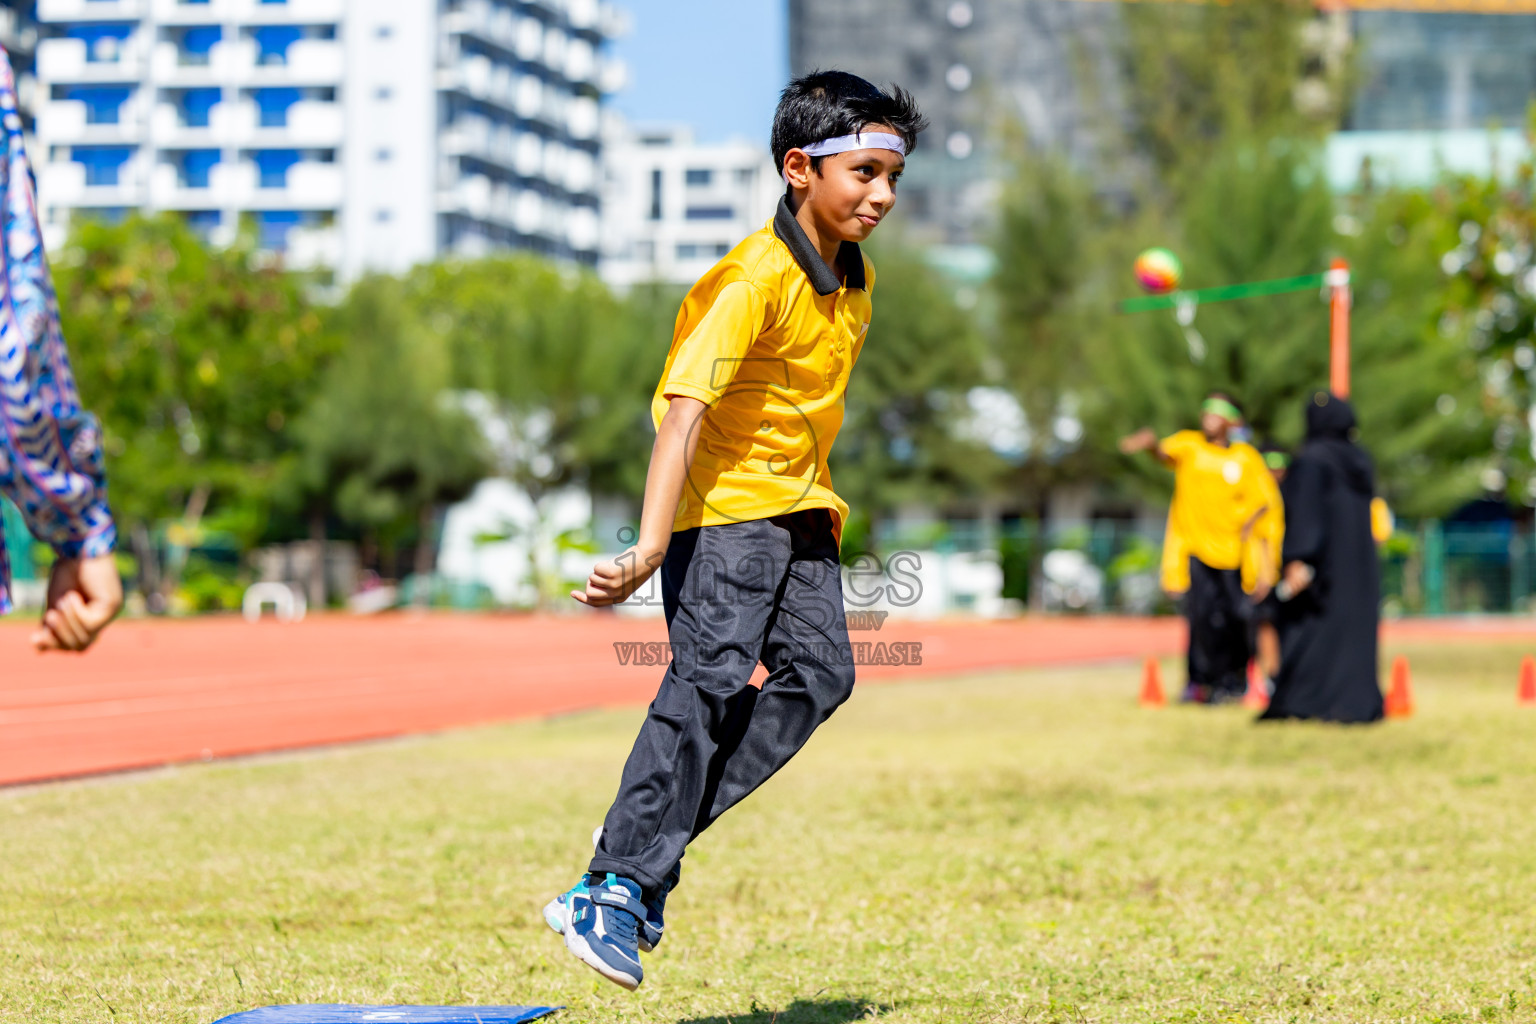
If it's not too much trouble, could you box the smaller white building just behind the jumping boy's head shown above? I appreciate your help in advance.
[601,124,783,289]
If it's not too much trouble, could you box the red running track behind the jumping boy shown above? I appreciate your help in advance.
[0,614,1536,785]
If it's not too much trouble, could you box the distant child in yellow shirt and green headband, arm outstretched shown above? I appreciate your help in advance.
[1120,391,1275,703]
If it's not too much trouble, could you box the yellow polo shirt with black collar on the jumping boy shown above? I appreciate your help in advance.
[651,201,874,539]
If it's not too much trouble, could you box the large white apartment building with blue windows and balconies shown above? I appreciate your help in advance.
[35,0,622,279]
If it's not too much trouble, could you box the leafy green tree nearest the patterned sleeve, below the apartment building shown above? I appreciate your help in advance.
[54,216,335,596]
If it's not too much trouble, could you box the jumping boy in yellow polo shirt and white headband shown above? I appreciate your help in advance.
[544,71,926,989]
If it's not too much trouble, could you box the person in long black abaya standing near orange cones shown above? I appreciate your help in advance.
[1261,391,1382,722]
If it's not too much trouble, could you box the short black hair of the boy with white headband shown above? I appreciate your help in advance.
[773,71,928,173]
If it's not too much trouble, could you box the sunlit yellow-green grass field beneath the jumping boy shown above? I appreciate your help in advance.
[0,646,1536,1024]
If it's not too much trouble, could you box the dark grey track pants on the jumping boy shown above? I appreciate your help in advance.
[590,508,854,895]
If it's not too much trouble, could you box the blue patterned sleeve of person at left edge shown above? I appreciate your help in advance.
[0,51,117,568]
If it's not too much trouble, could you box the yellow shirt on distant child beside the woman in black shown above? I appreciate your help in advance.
[1158,430,1278,593]
